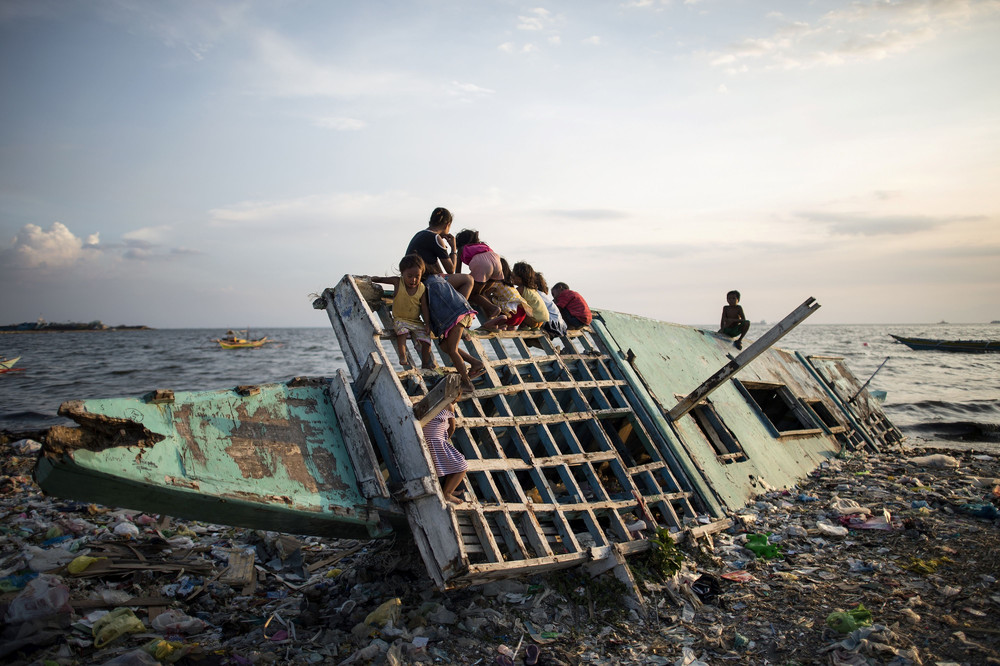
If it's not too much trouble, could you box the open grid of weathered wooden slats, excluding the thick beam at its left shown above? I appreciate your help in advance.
[344,274,697,578]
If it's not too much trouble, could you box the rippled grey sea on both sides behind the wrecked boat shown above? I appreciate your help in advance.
[0,324,1000,444]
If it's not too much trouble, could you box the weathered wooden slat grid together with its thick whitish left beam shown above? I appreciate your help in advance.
[324,276,704,587]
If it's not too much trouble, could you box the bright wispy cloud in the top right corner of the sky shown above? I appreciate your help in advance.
[705,0,1000,74]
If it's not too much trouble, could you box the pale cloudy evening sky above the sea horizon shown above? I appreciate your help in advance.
[0,0,1000,329]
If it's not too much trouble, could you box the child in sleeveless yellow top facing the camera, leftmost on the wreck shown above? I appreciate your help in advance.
[372,254,436,370]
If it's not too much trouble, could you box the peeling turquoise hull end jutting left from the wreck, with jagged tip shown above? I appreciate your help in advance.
[35,377,399,538]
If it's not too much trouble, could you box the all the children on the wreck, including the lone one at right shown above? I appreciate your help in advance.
[371,208,749,503]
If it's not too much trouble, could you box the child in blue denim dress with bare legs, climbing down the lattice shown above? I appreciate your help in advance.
[424,266,486,396]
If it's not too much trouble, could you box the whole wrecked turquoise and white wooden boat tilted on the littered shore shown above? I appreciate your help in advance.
[35,276,902,588]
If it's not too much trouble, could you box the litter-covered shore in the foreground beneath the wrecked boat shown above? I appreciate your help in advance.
[0,439,1000,666]
